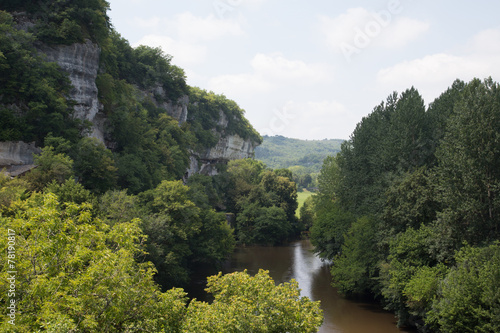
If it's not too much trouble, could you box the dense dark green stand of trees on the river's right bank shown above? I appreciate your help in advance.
[310,78,500,333]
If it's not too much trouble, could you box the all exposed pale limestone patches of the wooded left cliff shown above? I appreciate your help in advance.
[0,36,257,176]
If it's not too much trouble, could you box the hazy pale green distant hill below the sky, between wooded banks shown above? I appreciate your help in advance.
[255,135,344,173]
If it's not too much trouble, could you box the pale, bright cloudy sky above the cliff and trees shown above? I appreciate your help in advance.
[108,0,500,140]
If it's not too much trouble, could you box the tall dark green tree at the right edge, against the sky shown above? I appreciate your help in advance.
[437,78,500,245]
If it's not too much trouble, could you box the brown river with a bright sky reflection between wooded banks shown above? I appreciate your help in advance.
[189,240,416,333]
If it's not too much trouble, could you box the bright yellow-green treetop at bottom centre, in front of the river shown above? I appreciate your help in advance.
[183,270,323,333]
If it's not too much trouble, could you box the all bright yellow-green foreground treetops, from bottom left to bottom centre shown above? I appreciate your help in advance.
[0,193,322,333]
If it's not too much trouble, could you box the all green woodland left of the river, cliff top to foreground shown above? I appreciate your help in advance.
[0,0,322,332]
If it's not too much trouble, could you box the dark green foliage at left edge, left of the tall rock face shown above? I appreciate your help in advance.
[0,11,83,144]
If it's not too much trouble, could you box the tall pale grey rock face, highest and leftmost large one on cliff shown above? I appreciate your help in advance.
[38,40,104,143]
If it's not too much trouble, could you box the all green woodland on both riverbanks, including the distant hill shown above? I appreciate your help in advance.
[0,0,500,332]
